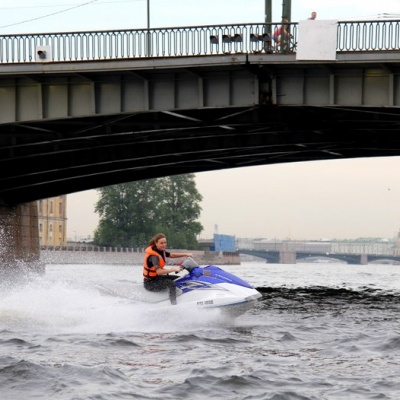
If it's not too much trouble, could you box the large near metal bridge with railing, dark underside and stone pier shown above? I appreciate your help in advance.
[0,20,400,268]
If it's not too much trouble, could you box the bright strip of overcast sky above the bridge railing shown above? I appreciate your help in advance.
[0,0,400,34]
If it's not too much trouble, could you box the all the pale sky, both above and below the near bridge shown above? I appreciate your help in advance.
[0,0,400,239]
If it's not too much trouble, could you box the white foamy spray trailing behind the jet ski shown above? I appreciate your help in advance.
[0,268,234,334]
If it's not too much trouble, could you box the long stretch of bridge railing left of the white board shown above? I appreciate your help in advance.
[0,23,288,63]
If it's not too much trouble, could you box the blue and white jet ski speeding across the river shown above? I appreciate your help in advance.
[136,257,262,316]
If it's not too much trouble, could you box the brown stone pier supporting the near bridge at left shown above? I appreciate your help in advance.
[0,202,44,276]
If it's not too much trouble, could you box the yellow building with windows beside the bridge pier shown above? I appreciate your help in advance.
[37,195,67,246]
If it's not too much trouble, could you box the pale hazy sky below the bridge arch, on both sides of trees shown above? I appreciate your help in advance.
[68,157,400,240]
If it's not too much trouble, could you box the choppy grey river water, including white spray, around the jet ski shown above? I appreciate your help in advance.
[0,262,400,400]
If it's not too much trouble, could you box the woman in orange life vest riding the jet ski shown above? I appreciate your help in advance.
[143,233,192,304]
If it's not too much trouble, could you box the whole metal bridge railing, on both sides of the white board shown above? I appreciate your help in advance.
[0,20,400,64]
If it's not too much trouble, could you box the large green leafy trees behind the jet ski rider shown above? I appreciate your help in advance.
[94,174,203,249]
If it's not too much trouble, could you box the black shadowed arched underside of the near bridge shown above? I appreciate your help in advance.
[0,105,400,204]
